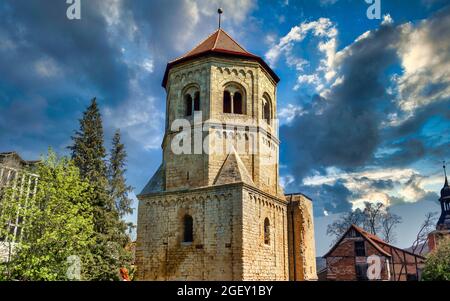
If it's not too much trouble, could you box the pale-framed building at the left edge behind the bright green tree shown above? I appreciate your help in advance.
[0,152,38,261]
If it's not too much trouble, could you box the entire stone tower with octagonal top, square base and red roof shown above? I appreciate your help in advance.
[136,29,315,280]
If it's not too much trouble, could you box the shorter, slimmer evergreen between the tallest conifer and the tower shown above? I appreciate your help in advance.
[108,130,133,218]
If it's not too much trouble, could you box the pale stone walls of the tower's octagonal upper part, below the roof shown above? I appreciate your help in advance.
[163,58,279,195]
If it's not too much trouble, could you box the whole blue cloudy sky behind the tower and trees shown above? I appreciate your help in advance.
[0,0,450,255]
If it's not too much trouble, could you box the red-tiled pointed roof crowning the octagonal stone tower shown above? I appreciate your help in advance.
[162,28,280,87]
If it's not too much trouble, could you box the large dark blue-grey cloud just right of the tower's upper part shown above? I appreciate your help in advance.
[280,22,398,179]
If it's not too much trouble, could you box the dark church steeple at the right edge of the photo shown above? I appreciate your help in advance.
[428,164,450,252]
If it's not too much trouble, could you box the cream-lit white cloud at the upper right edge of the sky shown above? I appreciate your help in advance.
[392,12,450,117]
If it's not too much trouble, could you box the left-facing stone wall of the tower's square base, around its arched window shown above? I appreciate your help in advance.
[136,185,242,280]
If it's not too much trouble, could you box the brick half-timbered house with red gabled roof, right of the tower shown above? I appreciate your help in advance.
[319,225,425,281]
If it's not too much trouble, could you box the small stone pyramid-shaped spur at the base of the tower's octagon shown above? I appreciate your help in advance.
[214,148,254,185]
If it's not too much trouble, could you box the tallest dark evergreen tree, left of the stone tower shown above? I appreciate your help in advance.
[69,98,130,280]
